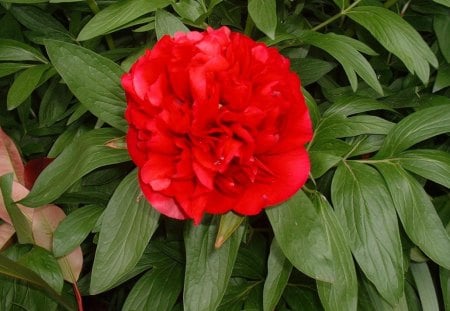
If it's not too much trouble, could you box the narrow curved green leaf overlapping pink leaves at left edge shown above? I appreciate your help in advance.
[0,173,34,244]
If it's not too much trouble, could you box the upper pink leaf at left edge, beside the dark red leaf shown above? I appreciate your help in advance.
[0,128,25,184]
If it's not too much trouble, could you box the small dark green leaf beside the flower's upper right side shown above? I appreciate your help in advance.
[291,57,336,86]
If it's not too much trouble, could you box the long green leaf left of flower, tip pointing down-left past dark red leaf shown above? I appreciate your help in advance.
[20,128,129,207]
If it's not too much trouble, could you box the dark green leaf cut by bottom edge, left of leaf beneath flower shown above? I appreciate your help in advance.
[122,263,183,311]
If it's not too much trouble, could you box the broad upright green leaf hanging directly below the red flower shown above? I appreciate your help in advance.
[183,218,244,311]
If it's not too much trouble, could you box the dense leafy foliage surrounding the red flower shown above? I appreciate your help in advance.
[0,0,450,311]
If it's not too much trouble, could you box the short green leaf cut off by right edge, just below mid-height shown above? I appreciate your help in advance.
[397,149,450,188]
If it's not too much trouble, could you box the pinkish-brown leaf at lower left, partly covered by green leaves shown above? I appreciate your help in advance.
[32,204,83,283]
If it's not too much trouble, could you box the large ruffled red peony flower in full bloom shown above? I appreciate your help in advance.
[122,27,312,224]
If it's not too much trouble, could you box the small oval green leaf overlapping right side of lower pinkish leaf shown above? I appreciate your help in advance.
[53,205,104,257]
